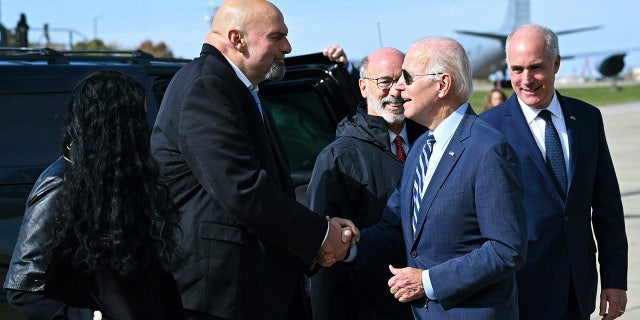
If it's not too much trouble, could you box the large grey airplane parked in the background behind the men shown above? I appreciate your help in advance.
[456,0,638,79]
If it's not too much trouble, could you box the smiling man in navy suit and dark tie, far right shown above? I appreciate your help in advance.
[481,25,628,320]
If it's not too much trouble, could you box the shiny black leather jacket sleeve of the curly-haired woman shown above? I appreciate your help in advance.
[4,157,67,292]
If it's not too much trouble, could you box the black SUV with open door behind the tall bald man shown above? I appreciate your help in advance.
[0,48,362,320]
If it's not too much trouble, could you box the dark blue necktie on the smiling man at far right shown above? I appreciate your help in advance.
[538,110,567,199]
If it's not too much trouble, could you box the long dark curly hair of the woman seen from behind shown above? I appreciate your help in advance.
[48,71,178,276]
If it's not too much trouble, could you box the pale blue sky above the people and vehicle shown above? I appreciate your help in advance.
[5,0,640,77]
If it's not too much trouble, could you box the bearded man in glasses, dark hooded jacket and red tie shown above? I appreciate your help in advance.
[307,48,425,320]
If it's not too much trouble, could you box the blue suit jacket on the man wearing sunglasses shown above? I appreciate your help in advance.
[356,107,526,319]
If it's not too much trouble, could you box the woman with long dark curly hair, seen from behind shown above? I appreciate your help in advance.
[5,71,183,320]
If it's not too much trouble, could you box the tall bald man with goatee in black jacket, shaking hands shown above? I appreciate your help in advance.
[151,0,358,320]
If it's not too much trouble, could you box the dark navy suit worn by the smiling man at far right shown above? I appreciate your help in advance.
[481,92,628,319]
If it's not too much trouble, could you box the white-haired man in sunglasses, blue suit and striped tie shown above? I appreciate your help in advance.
[336,37,526,320]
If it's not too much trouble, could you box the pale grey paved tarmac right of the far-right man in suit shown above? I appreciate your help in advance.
[591,101,640,320]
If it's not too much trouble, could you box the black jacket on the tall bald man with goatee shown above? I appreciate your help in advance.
[151,44,327,319]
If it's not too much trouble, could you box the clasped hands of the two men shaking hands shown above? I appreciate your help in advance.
[316,216,360,267]
